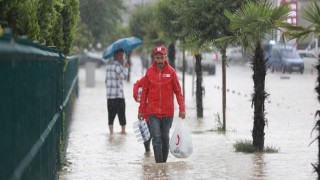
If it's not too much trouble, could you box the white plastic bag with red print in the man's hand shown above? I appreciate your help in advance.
[170,120,193,158]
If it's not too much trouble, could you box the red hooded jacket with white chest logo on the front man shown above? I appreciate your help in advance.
[139,61,185,118]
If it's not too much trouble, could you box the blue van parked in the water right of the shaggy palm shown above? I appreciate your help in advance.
[265,45,304,74]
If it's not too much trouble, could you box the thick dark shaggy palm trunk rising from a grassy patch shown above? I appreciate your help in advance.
[252,42,268,151]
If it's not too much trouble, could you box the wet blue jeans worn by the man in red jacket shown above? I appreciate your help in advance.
[149,115,173,163]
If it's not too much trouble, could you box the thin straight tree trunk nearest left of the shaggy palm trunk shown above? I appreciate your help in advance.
[221,47,227,132]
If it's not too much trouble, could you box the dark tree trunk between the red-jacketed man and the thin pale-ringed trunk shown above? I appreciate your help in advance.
[195,54,203,118]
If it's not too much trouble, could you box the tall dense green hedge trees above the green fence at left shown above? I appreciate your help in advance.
[0,0,79,54]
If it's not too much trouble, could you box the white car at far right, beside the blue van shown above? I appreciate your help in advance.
[298,50,318,73]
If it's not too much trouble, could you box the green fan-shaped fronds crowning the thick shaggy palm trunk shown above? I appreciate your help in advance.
[225,1,290,48]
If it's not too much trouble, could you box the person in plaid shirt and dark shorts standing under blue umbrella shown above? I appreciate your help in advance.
[105,49,129,134]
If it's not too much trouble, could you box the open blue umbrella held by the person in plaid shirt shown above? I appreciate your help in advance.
[103,37,143,59]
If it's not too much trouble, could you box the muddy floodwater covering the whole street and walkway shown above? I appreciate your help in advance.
[60,58,319,180]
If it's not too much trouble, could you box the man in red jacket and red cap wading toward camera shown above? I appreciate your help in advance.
[138,46,186,163]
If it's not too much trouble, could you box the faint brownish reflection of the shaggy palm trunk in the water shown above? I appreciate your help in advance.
[252,153,265,180]
